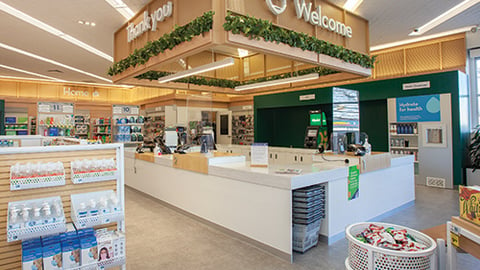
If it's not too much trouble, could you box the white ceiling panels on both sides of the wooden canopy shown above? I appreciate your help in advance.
[0,0,480,83]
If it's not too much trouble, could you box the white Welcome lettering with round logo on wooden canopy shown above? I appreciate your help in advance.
[265,0,353,38]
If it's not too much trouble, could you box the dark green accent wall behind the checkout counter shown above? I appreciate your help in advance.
[254,71,469,185]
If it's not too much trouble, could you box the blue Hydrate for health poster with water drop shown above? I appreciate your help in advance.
[397,95,440,122]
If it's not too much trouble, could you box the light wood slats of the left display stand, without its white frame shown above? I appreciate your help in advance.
[0,149,117,270]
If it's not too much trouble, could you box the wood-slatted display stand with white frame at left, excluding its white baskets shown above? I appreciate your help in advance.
[0,144,125,269]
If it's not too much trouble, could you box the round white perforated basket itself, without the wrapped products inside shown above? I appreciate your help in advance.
[345,222,437,270]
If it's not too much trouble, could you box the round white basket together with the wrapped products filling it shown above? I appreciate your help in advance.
[345,222,437,270]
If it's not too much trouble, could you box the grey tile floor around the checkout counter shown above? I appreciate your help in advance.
[125,186,480,270]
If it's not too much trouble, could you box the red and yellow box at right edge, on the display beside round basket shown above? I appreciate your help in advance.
[459,186,480,225]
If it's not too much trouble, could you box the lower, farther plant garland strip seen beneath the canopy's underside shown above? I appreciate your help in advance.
[135,67,338,89]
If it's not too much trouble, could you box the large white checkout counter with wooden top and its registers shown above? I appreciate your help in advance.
[125,89,415,261]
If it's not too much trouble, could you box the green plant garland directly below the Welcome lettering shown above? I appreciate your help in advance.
[223,12,376,68]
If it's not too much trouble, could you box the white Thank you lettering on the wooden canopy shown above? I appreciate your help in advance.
[127,1,173,42]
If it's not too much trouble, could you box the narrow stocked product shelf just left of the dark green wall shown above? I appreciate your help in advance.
[232,111,254,145]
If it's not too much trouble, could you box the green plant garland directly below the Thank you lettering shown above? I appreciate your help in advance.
[108,11,214,76]
